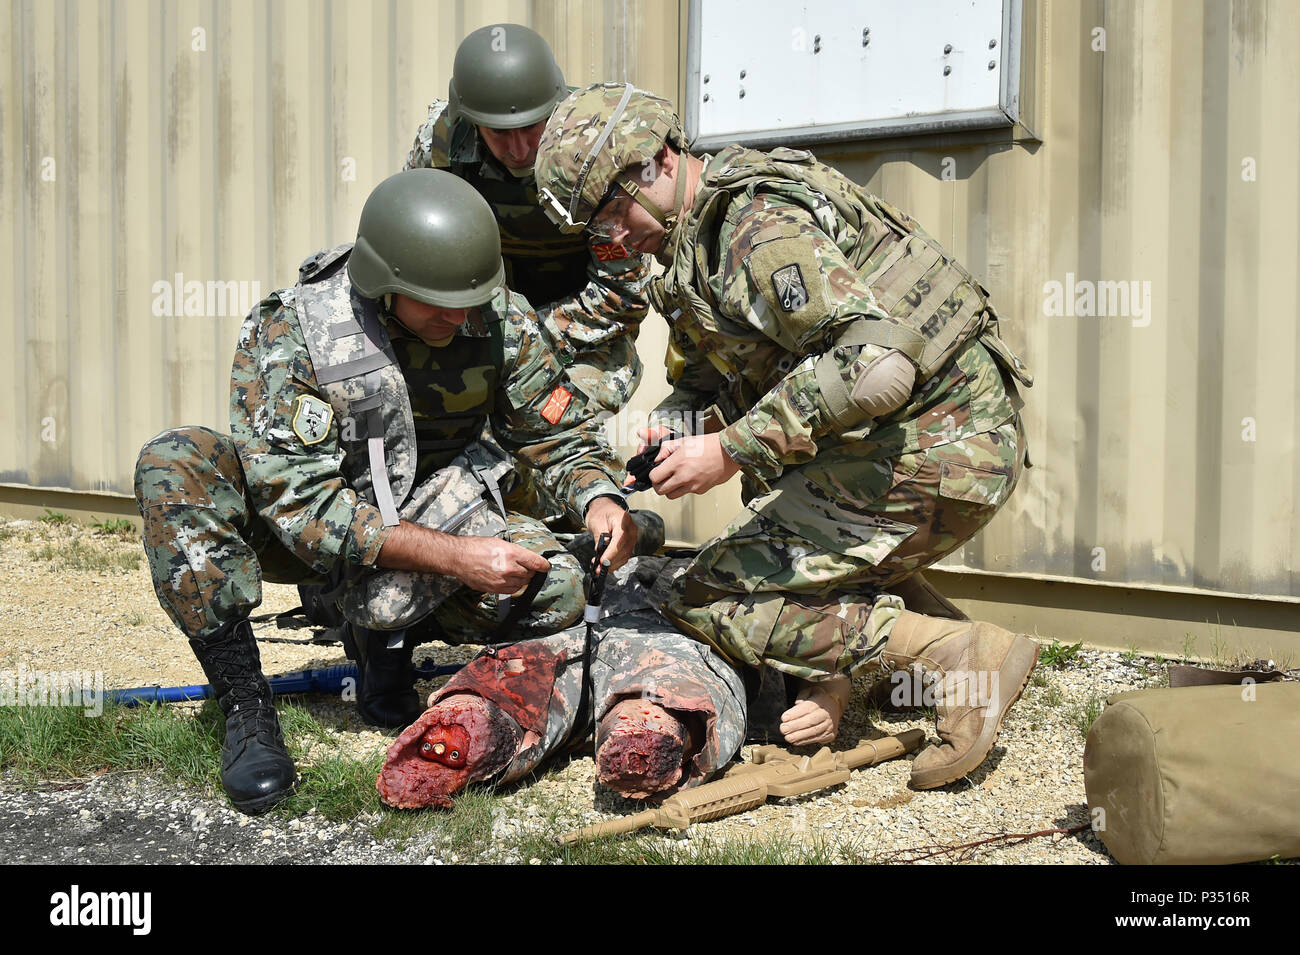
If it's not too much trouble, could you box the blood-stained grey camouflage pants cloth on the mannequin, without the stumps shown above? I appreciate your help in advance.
[436,609,745,787]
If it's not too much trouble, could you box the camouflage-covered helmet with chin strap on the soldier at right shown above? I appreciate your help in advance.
[533,83,686,240]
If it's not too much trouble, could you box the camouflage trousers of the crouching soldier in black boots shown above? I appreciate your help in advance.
[135,427,585,643]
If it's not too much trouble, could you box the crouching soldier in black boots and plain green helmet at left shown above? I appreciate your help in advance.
[135,170,636,812]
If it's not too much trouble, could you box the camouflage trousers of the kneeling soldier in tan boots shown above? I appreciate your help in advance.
[664,417,1024,680]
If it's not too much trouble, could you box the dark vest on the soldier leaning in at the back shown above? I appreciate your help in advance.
[439,110,592,308]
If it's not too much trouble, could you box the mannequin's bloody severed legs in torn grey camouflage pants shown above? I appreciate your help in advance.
[378,557,746,808]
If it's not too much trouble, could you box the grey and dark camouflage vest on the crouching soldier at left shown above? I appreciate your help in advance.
[295,243,503,526]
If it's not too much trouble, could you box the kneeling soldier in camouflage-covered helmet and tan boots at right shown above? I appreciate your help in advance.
[536,84,1037,789]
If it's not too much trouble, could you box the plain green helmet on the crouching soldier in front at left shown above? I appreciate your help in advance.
[347,169,506,308]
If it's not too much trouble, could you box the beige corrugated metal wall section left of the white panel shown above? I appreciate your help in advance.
[0,0,679,492]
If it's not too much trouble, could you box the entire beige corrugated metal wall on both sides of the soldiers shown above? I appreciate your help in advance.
[0,0,1300,599]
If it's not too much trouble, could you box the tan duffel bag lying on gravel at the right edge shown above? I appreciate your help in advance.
[1083,682,1300,865]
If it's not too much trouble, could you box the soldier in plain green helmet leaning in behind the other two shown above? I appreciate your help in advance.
[403,23,650,412]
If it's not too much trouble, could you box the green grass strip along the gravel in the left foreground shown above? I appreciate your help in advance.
[0,700,871,865]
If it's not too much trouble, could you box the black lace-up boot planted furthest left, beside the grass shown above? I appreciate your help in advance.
[190,620,298,816]
